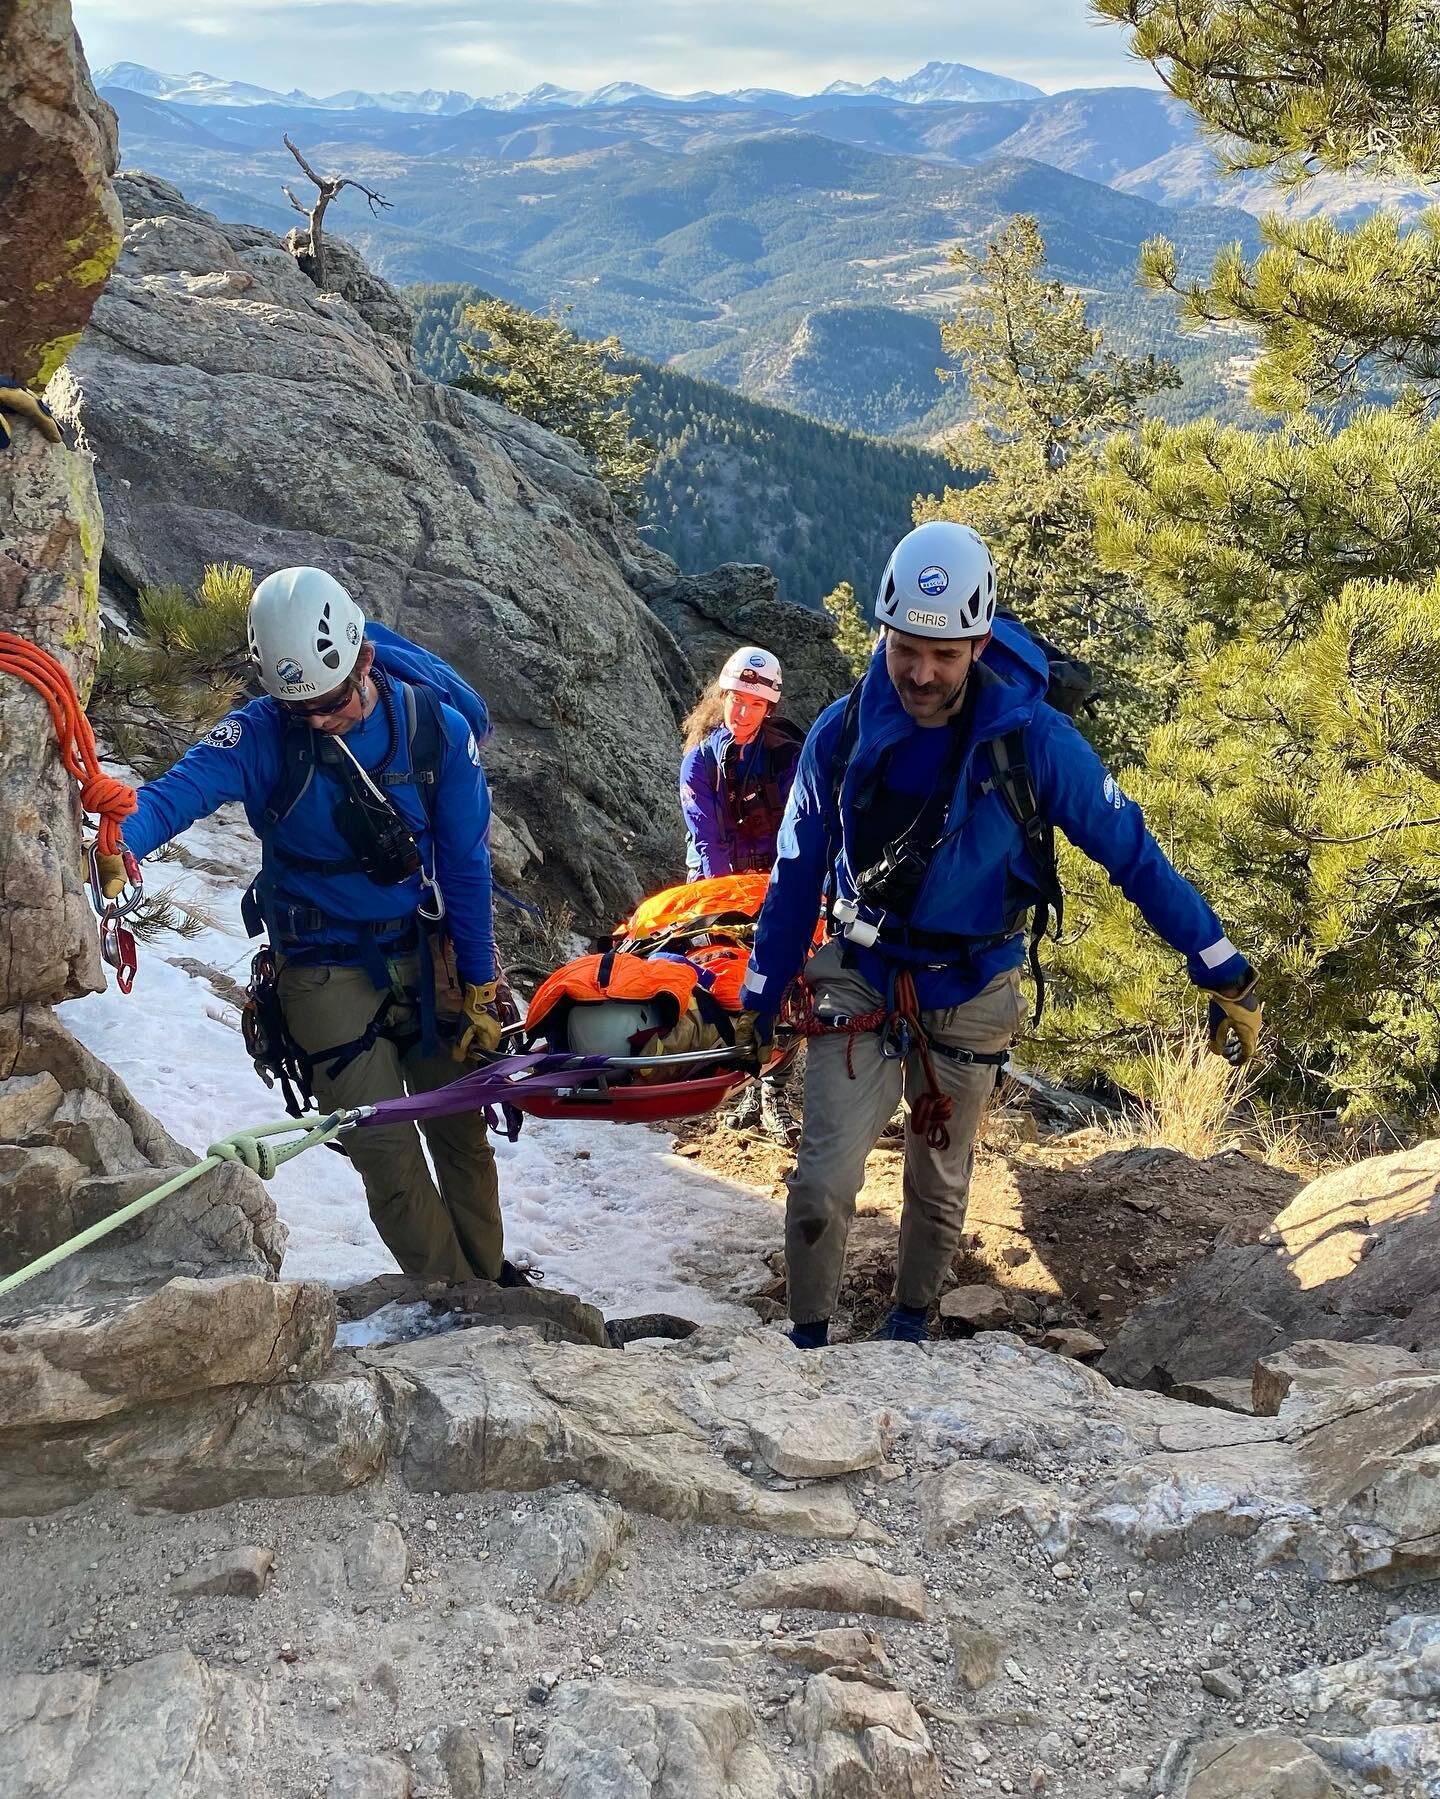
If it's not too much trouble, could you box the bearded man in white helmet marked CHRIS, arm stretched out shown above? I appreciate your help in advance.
[736,520,1260,1347]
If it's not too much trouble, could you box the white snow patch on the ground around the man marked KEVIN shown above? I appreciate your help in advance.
[65,806,781,1322]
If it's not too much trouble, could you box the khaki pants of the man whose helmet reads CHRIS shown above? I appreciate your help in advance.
[785,941,1024,1324]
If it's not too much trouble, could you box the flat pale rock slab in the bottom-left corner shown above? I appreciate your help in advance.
[0,1650,266,1799]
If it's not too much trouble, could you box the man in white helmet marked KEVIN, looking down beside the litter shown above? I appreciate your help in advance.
[92,568,508,1281]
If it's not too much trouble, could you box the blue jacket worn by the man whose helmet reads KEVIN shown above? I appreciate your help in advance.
[124,644,495,982]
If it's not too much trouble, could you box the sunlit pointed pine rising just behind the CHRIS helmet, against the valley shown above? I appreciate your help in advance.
[914,214,1179,756]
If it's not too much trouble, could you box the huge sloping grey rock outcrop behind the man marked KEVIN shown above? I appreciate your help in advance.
[54,173,846,928]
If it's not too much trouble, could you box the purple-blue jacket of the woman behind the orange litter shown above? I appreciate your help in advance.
[680,718,801,880]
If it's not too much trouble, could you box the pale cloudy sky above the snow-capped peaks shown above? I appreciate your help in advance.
[76,0,1154,94]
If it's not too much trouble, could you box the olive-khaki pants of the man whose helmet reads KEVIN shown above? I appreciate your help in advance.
[279,955,504,1281]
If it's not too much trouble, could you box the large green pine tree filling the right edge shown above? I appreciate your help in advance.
[1046,0,1440,1119]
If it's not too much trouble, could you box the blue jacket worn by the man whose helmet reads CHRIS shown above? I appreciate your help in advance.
[743,619,1246,1011]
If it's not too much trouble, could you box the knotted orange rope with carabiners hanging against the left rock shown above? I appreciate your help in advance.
[0,631,144,993]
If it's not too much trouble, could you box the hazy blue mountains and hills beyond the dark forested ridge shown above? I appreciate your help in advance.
[103,70,1258,441]
